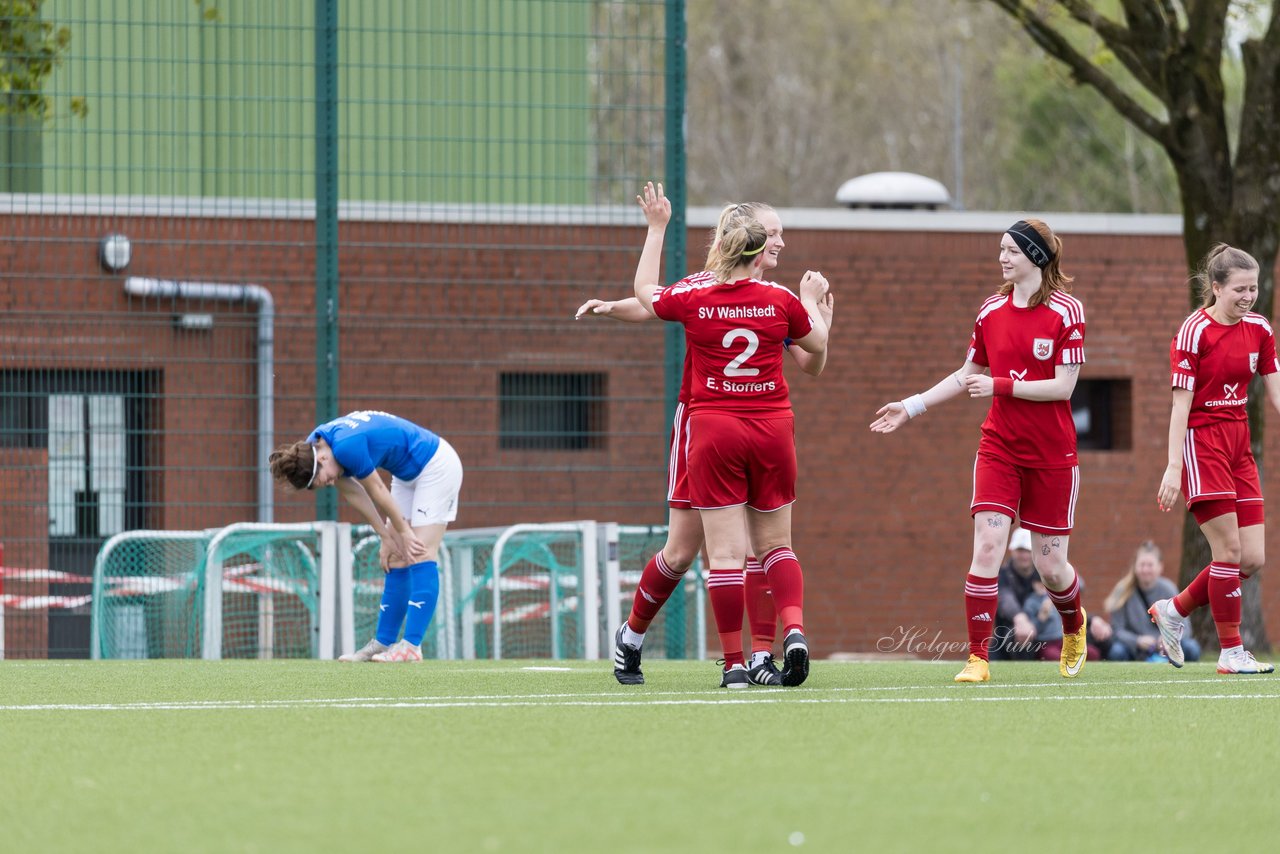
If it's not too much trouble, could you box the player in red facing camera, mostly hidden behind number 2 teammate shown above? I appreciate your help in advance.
[575,182,835,686]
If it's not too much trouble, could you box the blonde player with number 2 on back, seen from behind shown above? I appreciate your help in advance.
[635,188,827,688]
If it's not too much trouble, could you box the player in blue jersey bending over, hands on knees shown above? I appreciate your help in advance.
[269,410,462,662]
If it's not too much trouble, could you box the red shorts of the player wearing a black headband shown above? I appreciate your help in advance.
[969,451,1080,534]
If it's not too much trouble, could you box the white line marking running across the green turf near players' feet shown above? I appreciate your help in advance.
[0,679,1280,712]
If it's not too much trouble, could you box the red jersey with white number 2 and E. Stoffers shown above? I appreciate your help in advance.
[653,273,813,417]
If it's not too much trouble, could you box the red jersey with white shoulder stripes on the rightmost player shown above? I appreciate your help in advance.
[1169,309,1280,428]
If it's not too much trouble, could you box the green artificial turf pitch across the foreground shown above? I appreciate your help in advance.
[0,661,1280,854]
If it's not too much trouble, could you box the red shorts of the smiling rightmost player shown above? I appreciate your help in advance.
[1183,421,1263,528]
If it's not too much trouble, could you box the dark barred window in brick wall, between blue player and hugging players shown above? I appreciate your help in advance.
[498,373,605,451]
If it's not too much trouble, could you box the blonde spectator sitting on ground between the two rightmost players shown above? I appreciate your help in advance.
[1106,540,1201,662]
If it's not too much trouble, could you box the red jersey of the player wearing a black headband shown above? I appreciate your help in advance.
[966,291,1084,469]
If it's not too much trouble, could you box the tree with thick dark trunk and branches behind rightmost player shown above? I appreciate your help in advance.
[978,0,1280,648]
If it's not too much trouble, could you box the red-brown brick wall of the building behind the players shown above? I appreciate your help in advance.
[0,211,1280,654]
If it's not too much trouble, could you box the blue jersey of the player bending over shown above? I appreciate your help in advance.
[307,410,440,480]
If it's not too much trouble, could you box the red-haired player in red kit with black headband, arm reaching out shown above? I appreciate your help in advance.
[870,219,1088,682]
